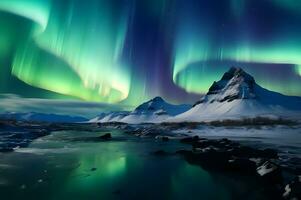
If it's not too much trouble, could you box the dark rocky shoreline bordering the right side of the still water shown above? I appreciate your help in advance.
[153,136,301,199]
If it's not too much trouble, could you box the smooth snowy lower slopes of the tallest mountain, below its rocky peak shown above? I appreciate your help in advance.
[167,99,301,122]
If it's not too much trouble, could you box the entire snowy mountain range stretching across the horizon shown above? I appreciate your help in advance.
[0,67,301,124]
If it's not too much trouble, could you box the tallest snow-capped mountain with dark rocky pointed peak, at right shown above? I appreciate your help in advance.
[169,67,301,122]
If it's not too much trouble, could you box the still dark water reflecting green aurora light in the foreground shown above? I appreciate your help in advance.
[0,130,268,200]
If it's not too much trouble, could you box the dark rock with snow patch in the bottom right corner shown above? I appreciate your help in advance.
[283,176,301,199]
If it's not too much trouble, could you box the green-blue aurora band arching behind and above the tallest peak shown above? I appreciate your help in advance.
[173,0,301,95]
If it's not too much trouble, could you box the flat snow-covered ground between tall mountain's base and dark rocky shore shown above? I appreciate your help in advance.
[173,125,301,159]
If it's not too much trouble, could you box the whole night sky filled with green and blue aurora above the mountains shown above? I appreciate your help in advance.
[0,0,301,105]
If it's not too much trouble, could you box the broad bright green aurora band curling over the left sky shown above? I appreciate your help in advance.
[0,0,130,102]
